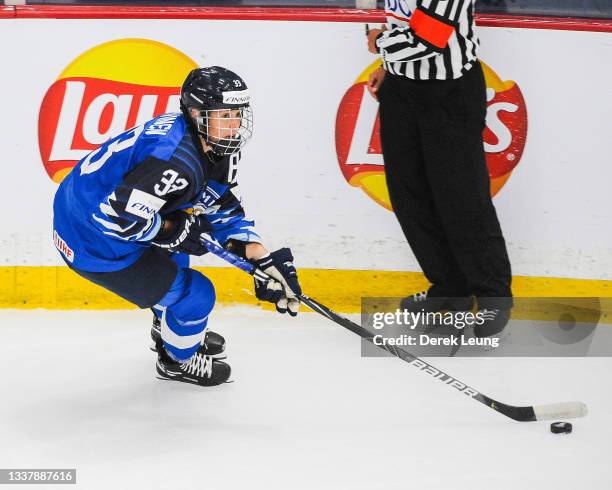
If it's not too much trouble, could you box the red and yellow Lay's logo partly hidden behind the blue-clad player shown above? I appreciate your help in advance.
[38,39,197,183]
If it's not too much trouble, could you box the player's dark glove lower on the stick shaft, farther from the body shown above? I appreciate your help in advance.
[251,248,302,316]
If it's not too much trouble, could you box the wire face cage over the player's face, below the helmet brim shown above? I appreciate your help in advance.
[196,107,253,155]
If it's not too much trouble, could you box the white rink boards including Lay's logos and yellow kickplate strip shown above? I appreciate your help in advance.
[0,14,612,311]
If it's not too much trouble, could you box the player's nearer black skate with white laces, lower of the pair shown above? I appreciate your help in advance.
[155,338,232,386]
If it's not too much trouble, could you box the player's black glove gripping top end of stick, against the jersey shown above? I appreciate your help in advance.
[152,211,212,255]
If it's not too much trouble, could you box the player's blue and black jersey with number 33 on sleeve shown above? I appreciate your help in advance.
[53,113,261,272]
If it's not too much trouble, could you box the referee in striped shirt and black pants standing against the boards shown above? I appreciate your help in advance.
[368,0,512,337]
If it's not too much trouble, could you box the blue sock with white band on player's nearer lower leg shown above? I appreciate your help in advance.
[156,269,215,361]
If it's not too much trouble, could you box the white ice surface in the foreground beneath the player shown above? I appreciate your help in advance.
[0,307,612,490]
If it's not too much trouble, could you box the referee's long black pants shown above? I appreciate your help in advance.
[378,60,512,307]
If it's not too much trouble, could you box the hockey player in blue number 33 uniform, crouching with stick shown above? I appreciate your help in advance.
[53,66,301,386]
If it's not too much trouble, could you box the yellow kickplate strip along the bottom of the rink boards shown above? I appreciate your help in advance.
[0,266,612,323]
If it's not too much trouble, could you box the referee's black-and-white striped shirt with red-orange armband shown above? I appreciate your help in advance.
[376,0,479,80]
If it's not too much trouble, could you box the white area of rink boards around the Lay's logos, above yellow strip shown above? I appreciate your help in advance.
[0,19,612,279]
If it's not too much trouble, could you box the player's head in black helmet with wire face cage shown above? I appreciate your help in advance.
[181,66,253,155]
